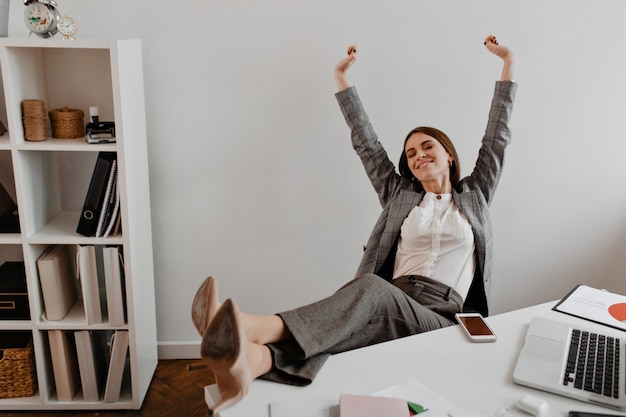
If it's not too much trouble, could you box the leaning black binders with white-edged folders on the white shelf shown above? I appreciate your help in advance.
[76,152,120,237]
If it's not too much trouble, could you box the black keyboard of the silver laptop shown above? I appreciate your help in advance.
[563,329,620,398]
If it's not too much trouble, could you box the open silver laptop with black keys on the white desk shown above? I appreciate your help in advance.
[513,317,626,410]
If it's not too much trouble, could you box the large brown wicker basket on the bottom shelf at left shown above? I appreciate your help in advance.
[0,334,37,398]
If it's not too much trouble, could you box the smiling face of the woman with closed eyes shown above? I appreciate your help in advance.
[404,132,452,186]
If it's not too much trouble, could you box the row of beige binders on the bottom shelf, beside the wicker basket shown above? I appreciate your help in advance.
[48,330,130,402]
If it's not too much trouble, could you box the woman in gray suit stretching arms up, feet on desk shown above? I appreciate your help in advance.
[192,36,517,413]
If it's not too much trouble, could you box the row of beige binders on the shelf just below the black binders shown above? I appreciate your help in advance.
[37,245,126,326]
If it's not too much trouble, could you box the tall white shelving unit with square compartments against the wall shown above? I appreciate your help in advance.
[0,38,157,410]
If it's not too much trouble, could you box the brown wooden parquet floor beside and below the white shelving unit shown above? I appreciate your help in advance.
[0,360,215,417]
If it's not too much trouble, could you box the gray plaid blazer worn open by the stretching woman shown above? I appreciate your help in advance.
[336,81,517,316]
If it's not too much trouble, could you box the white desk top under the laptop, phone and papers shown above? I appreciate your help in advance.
[207,301,624,417]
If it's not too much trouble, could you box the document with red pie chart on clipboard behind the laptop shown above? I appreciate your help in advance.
[553,285,626,331]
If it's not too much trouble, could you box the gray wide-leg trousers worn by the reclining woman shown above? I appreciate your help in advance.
[261,274,463,385]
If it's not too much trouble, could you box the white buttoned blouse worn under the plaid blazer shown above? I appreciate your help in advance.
[393,192,476,299]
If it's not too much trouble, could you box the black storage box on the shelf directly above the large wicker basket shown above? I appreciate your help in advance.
[0,262,30,320]
